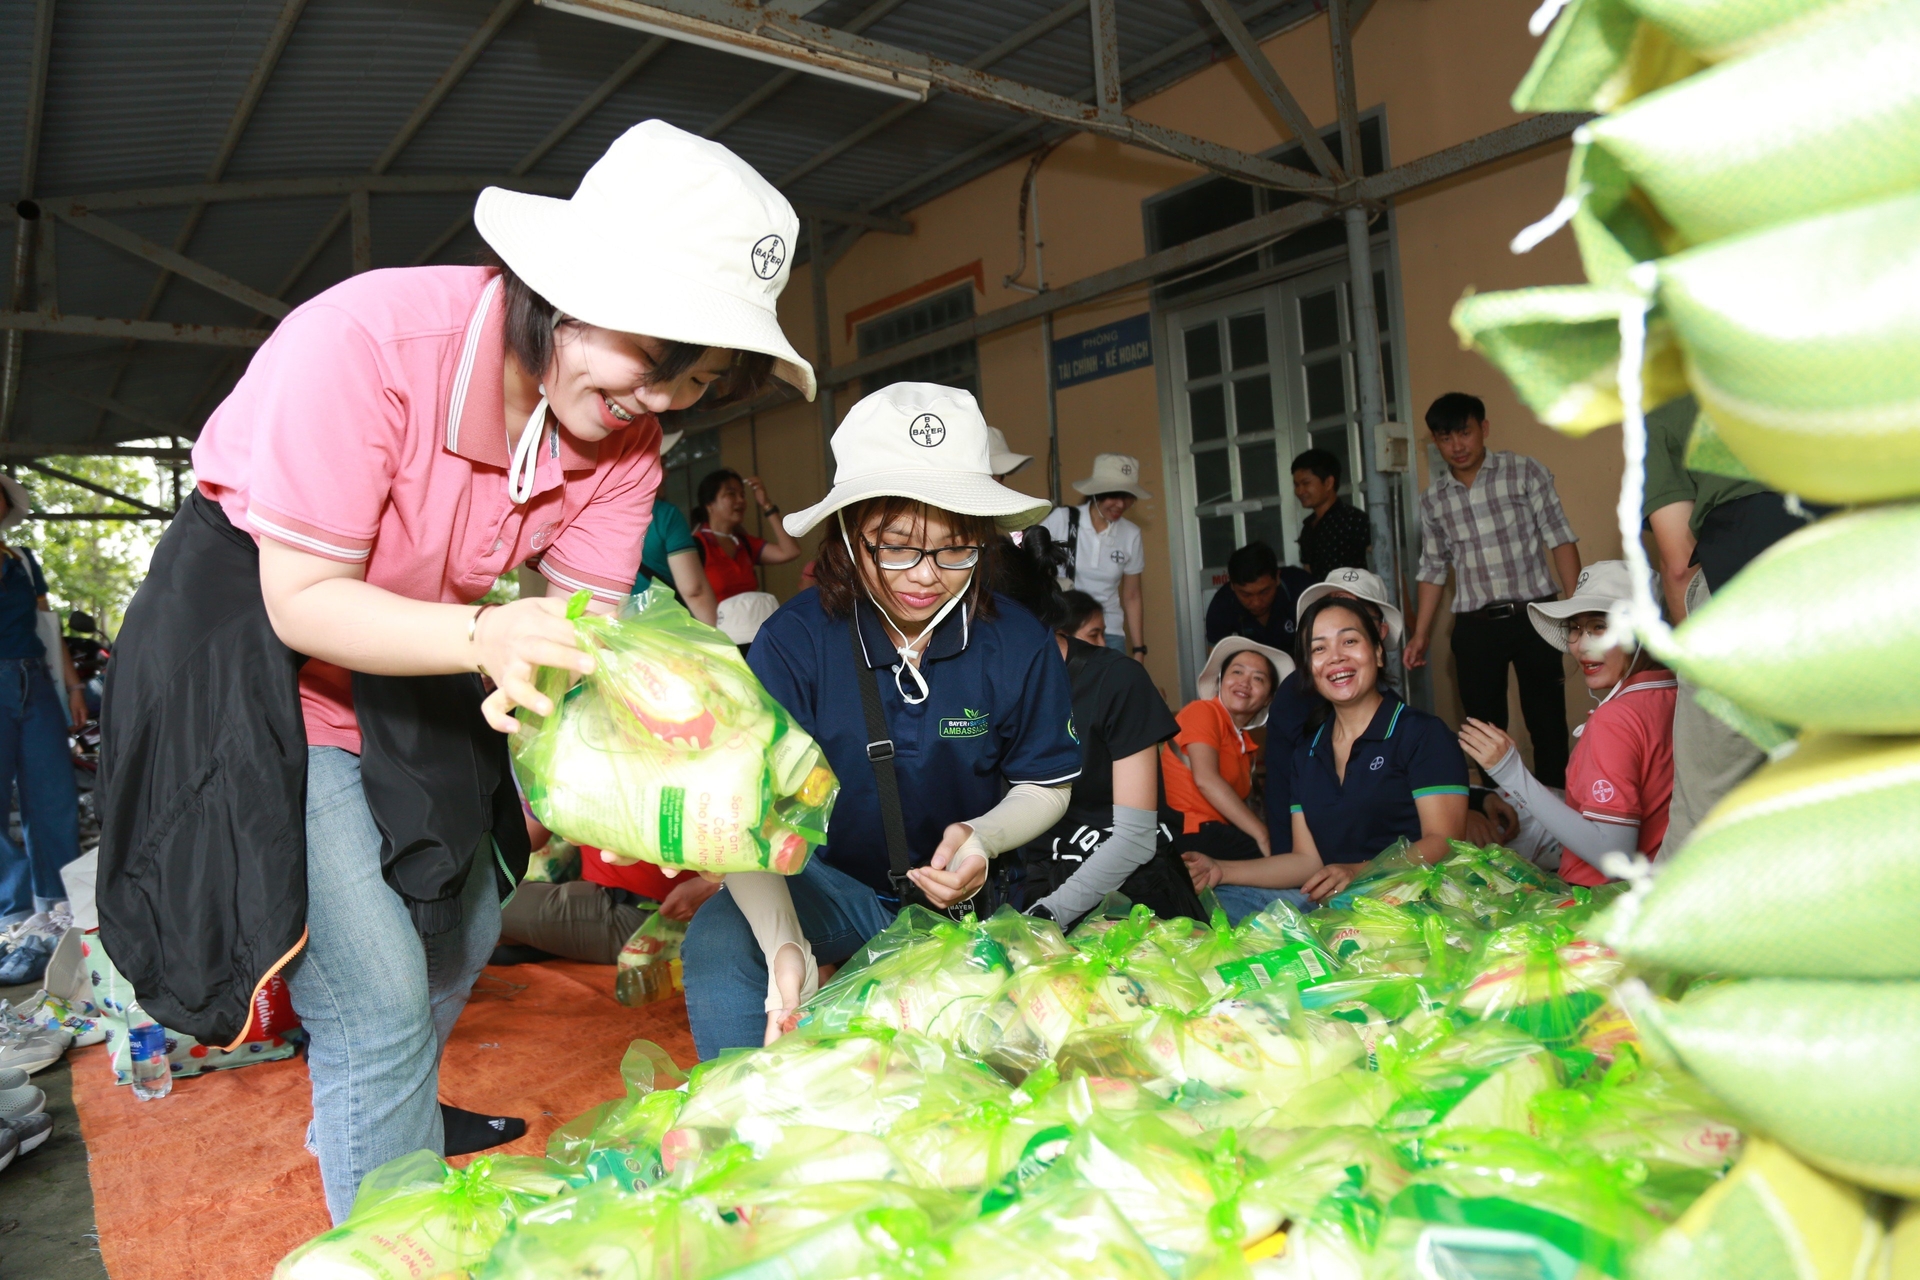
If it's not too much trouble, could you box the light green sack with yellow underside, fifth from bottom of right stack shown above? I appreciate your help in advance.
[1659,189,1920,503]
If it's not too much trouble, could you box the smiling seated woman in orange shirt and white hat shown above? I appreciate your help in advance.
[1160,635,1294,860]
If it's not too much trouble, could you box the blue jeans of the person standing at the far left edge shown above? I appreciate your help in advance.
[0,658,81,925]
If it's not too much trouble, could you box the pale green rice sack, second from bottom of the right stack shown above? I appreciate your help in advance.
[1622,974,1920,1196]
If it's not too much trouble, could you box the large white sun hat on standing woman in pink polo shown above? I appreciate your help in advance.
[474,121,814,399]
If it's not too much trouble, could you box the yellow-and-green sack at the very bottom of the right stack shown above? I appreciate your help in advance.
[1634,1138,1884,1280]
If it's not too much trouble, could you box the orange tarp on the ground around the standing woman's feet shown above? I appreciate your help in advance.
[73,961,693,1280]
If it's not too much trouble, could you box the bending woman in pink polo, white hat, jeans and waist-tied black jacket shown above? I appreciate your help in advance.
[100,121,814,1221]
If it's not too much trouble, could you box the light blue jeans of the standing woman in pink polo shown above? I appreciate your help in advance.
[286,747,499,1222]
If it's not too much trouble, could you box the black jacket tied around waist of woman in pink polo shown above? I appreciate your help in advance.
[98,493,528,1044]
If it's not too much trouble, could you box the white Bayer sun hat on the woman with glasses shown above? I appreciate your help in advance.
[785,382,1052,537]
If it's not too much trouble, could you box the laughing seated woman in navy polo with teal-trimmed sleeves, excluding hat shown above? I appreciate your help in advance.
[1187,597,1467,906]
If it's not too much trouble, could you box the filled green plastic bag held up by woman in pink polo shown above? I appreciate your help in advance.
[511,587,839,875]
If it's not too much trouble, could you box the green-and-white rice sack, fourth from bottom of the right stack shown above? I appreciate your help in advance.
[1663,503,1920,733]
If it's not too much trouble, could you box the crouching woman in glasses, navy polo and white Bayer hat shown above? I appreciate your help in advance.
[682,382,1081,1059]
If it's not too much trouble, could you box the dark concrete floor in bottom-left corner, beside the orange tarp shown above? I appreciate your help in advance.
[0,986,108,1280]
